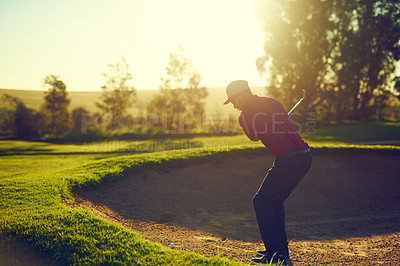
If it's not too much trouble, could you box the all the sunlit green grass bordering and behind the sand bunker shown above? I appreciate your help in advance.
[0,123,400,265]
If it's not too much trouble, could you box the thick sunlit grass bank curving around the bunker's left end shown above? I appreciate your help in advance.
[0,149,266,265]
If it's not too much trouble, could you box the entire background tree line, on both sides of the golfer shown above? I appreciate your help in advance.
[0,0,400,138]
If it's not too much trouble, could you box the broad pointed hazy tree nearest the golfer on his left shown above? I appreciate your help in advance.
[147,46,208,132]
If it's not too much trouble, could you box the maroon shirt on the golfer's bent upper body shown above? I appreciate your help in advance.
[239,95,309,157]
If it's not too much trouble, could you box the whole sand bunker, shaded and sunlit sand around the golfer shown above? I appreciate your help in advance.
[75,152,400,265]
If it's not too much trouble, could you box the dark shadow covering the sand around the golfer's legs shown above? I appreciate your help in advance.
[77,152,400,242]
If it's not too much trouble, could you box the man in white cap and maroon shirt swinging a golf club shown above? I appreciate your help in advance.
[224,80,311,265]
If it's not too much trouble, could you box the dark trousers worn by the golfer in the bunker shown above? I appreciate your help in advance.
[253,152,311,254]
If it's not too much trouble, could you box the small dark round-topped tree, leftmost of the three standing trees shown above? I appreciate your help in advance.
[42,75,71,134]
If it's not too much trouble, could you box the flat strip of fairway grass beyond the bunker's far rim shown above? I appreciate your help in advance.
[0,122,400,155]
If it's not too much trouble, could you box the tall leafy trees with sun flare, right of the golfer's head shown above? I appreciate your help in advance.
[257,0,400,122]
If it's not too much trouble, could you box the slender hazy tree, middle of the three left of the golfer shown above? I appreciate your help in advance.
[96,57,136,129]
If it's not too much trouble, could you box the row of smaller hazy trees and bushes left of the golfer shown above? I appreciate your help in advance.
[0,46,227,139]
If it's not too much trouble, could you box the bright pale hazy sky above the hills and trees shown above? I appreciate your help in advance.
[0,0,265,91]
